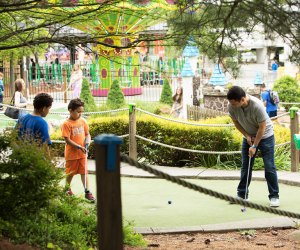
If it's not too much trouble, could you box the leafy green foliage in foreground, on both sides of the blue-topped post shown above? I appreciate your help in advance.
[0,133,145,250]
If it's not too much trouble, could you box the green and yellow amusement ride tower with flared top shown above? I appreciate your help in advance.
[53,0,176,96]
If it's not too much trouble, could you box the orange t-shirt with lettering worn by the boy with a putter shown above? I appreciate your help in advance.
[61,118,89,161]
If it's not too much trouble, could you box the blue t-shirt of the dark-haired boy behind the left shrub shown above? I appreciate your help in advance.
[17,114,52,145]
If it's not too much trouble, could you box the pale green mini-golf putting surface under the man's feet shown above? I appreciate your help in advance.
[65,175,300,228]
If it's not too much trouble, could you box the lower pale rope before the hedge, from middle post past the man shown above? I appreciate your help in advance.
[135,135,291,155]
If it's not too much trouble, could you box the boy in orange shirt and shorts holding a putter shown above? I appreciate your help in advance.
[61,98,95,201]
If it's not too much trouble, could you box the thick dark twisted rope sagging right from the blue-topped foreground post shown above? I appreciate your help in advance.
[121,154,300,219]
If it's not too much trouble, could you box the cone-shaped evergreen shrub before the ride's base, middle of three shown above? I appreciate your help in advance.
[106,80,125,109]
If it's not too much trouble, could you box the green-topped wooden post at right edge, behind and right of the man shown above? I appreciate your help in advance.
[290,107,299,172]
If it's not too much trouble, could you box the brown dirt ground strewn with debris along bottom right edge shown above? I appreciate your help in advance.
[125,229,300,250]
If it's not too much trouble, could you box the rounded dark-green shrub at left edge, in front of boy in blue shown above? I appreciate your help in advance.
[0,133,62,219]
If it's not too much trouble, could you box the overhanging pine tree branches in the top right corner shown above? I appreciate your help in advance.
[168,0,300,63]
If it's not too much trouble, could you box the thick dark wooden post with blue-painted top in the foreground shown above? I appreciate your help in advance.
[94,134,123,250]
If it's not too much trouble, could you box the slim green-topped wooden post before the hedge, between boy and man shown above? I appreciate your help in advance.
[129,103,137,160]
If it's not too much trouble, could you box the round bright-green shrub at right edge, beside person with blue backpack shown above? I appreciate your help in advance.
[273,76,300,110]
